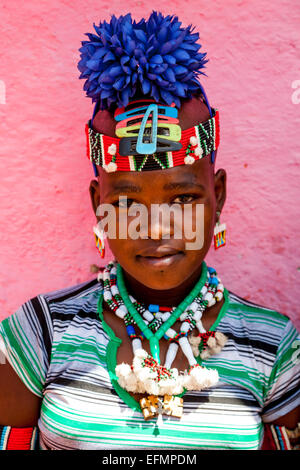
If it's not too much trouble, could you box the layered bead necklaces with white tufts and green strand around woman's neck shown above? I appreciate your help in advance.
[98,261,226,419]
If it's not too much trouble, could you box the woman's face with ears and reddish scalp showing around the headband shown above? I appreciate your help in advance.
[90,96,226,290]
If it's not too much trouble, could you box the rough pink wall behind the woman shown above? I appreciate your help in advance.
[0,0,300,327]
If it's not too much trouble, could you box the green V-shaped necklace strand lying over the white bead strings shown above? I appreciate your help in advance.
[117,261,207,363]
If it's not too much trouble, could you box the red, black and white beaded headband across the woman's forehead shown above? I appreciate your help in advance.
[86,108,220,172]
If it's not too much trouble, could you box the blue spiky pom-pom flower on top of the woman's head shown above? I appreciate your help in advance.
[78,11,207,109]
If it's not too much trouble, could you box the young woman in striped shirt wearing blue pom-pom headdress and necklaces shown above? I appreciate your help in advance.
[0,12,299,449]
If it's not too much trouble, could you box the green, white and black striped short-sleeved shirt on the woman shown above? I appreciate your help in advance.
[0,279,300,450]
